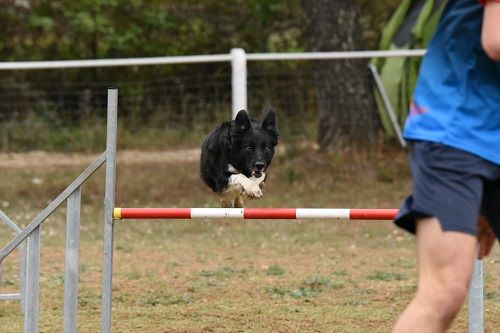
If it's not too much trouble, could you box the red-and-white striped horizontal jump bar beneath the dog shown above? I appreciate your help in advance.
[113,208,398,220]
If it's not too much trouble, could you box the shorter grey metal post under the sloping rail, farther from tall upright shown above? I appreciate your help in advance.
[24,226,41,333]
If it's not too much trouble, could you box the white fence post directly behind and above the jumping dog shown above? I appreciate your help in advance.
[231,48,247,119]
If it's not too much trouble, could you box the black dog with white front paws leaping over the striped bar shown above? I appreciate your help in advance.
[200,110,278,208]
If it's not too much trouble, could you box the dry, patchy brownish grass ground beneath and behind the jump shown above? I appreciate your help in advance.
[0,147,500,333]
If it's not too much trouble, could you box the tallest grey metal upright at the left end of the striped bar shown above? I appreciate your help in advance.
[101,88,118,333]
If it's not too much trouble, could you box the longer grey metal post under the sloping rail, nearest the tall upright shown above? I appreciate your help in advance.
[63,187,81,333]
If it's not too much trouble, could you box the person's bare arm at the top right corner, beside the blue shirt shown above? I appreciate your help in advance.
[481,0,500,61]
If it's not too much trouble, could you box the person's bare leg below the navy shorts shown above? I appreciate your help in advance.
[392,217,476,333]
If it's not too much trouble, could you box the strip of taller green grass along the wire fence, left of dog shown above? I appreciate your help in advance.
[0,112,223,152]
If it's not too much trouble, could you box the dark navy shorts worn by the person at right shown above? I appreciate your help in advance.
[394,141,500,239]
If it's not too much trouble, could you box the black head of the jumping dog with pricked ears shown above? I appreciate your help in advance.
[230,109,279,178]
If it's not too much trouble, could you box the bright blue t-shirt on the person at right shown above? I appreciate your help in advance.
[403,0,500,164]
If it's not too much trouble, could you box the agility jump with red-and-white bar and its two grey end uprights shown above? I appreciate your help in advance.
[101,88,483,333]
